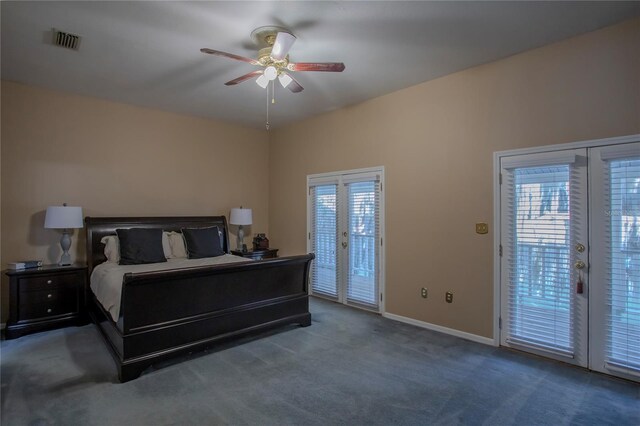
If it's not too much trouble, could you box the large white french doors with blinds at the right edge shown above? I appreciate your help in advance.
[500,143,640,380]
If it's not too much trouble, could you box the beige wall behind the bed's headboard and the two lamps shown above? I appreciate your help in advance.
[1,81,269,322]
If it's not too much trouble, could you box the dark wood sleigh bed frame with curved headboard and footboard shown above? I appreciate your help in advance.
[85,216,314,382]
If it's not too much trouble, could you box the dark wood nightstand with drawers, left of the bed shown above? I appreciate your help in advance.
[5,264,88,339]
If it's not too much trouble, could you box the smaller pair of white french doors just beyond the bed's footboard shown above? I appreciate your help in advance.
[307,168,383,312]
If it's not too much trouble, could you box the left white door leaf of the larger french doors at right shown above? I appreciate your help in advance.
[501,149,589,366]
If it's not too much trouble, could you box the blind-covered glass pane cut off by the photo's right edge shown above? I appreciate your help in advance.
[607,160,640,371]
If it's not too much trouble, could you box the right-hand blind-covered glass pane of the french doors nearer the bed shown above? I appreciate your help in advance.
[347,181,379,307]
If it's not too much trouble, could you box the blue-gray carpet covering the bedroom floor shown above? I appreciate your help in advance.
[0,299,640,426]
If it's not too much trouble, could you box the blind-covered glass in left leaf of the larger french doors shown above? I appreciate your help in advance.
[507,165,573,353]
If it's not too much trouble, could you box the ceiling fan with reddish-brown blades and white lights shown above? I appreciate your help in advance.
[200,26,344,93]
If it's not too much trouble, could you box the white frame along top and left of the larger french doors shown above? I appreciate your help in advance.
[493,133,640,346]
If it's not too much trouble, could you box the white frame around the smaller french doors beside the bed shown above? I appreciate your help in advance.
[305,166,386,315]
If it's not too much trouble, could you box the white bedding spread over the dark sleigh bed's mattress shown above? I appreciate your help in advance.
[91,254,251,321]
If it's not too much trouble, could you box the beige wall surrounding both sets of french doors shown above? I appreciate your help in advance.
[269,19,640,337]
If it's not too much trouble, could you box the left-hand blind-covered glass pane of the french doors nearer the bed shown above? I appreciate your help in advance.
[311,185,338,298]
